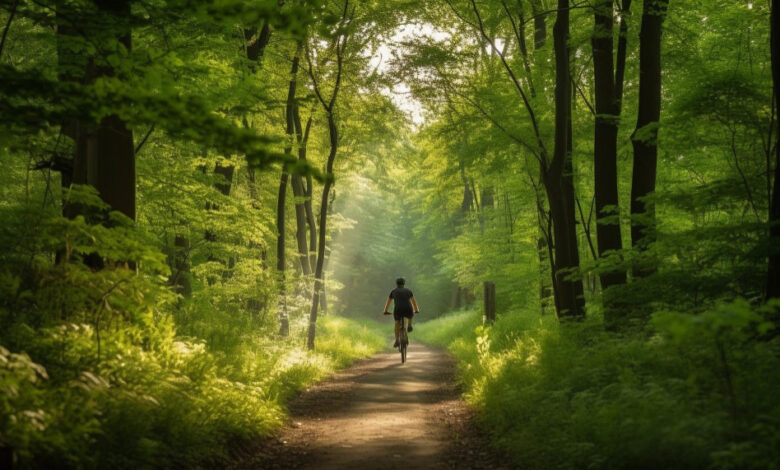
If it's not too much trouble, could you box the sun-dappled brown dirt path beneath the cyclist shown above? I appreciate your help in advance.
[231,344,511,470]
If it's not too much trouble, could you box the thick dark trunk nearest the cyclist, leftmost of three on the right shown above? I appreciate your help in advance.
[544,0,585,318]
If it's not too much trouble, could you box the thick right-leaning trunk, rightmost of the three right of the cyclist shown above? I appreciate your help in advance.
[631,0,669,277]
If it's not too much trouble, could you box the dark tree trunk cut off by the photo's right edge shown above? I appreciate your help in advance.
[766,0,780,299]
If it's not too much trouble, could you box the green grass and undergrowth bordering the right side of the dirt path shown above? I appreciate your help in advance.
[416,301,780,469]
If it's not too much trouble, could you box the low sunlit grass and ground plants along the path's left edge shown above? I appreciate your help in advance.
[0,316,386,469]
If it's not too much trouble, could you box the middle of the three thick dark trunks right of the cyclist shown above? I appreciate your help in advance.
[592,0,626,289]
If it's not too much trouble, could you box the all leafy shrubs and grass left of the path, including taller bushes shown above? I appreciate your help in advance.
[0,190,385,469]
